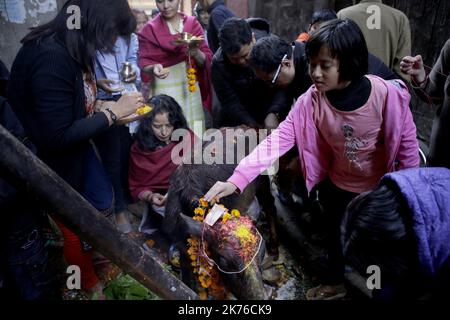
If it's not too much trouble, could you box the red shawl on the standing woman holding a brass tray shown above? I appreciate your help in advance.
[138,13,213,112]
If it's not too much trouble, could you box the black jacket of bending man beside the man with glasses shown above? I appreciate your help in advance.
[211,19,290,126]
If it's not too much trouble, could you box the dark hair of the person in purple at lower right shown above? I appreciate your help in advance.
[341,181,419,284]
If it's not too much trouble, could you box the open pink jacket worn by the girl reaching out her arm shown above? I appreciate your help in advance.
[228,75,420,192]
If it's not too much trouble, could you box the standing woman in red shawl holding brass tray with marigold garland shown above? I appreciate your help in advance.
[139,0,213,134]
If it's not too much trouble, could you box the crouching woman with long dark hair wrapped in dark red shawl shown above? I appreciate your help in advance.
[128,95,195,231]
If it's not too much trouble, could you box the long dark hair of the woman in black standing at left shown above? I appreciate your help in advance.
[22,0,136,72]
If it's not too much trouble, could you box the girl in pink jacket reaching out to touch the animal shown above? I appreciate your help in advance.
[205,19,419,300]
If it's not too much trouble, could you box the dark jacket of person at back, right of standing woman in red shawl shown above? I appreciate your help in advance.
[207,0,236,53]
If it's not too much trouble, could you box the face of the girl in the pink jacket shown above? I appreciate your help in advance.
[309,44,350,92]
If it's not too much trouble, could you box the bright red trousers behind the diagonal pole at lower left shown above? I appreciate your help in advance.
[55,219,99,289]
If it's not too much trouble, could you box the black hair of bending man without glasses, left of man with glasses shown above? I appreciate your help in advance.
[219,17,253,54]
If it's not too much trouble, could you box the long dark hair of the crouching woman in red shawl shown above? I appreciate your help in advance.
[135,94,188,151]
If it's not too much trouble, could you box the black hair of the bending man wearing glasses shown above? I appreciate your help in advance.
[250,35,292,73]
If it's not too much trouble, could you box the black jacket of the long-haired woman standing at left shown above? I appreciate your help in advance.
[8,37,108,190]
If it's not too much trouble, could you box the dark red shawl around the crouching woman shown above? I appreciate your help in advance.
[128,132,196,200]
